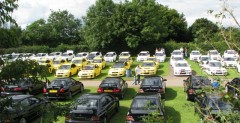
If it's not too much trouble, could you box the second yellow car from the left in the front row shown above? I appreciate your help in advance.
[78,64,102,79]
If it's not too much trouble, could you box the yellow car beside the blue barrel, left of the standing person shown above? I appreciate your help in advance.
[108,61,130,76]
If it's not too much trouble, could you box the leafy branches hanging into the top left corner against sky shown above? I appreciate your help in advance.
[0,0,18,26]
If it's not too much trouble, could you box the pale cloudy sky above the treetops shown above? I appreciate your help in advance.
[12,0,240,28]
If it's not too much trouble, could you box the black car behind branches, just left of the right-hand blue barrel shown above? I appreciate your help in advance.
[183,75,212,100]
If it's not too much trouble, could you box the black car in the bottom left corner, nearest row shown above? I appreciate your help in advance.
[0,95,48,123]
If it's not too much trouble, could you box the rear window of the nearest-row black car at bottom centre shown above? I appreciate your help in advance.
[131,98,158,110]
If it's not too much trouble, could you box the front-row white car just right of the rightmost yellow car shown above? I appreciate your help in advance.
[173,60,192,76]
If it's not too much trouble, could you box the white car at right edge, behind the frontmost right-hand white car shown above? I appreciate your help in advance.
[222,57,238,68]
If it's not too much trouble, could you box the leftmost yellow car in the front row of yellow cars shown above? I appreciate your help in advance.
[56,63,78,77]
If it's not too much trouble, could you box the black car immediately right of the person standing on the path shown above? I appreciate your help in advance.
[138,76,167,99]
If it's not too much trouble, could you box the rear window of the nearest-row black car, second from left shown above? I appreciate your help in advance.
[74,98,98,110]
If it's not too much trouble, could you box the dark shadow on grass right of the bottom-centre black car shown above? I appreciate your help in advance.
[165,106,181,123]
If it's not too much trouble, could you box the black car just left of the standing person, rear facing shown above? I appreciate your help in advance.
[97,77,128,99]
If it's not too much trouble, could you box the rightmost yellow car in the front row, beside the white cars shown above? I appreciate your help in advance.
[140,61,157,75]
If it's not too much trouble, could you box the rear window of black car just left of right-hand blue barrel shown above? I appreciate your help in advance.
[191,76,211,89]
